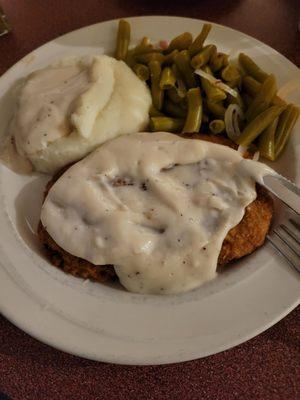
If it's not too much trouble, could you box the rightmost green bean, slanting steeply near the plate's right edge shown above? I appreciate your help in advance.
[275,104,299,158]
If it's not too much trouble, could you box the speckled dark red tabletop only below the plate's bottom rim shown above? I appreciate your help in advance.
[0,308,300,400]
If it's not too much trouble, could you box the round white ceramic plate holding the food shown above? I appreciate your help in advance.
[0,17,300,364]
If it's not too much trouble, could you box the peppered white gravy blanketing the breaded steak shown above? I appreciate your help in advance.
[41,132,272,294]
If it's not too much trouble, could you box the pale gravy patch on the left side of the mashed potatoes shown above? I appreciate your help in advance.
[12,65,89,155]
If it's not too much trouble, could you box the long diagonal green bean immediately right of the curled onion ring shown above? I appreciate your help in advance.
[236,106,285,146]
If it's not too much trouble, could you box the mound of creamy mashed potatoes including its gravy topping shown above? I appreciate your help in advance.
[12,55,151,173]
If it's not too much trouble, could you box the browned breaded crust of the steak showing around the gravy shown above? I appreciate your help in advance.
[38,133,274,283]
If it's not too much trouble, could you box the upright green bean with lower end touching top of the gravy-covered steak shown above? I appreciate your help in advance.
[182,88,202,132]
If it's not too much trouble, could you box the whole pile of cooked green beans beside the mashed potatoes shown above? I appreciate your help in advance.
[115,20,299,161]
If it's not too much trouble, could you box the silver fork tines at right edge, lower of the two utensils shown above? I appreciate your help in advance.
[267,212,300,272]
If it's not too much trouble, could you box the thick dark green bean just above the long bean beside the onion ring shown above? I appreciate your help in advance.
[245,75,277,121]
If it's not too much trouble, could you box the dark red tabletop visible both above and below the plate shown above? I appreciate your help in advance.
[0,0,300,400]
